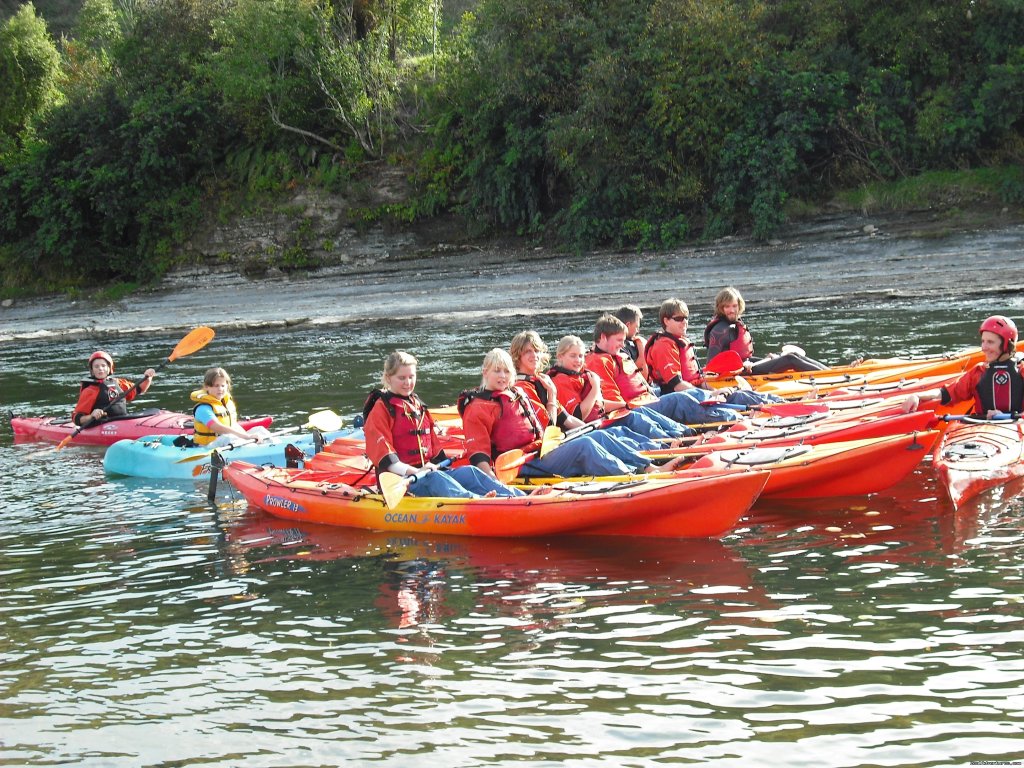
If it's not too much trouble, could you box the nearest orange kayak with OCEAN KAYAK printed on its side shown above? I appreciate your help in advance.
[224,462,768,538]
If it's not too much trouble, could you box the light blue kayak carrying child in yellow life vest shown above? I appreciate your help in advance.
[103,429,361,480]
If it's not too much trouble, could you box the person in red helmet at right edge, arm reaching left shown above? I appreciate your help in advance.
[903,314,1024,419]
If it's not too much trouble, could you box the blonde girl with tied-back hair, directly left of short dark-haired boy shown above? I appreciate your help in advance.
[548,336,693,447]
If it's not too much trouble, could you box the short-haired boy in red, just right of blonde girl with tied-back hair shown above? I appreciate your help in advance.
[585,314,736,424]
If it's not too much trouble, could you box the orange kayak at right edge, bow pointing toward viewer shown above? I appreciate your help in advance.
[932,420,1024,509]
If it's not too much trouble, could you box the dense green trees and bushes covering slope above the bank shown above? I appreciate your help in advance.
[0,0,1024,290]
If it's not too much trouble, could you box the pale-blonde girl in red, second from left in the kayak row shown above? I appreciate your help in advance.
[459,348,685,477]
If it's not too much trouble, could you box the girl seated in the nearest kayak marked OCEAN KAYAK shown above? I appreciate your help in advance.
[362,350,522,499]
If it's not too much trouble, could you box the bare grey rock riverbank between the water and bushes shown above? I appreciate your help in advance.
[0,209,1024,343]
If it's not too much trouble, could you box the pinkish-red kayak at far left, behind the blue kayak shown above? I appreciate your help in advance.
[10,408,273,445]
